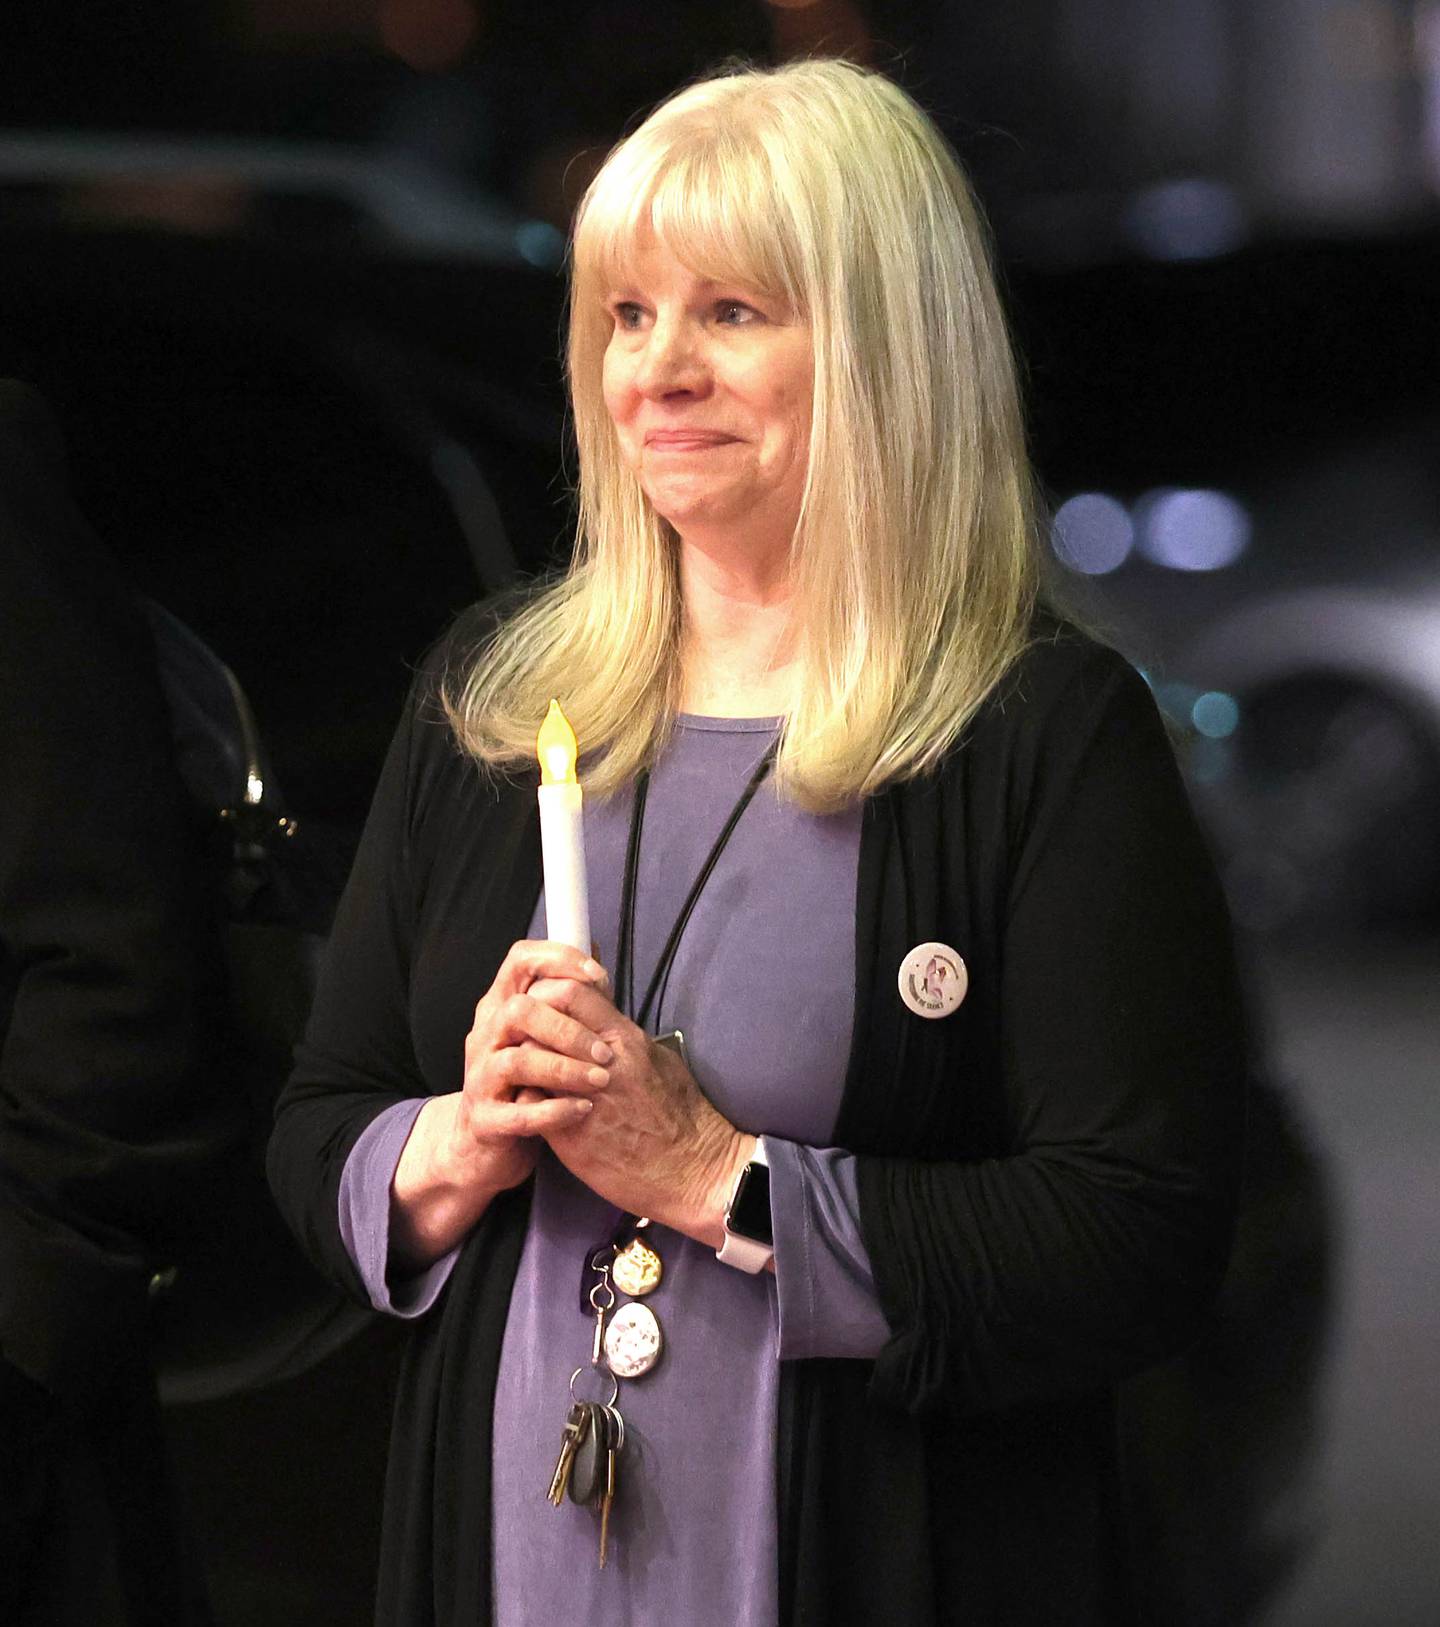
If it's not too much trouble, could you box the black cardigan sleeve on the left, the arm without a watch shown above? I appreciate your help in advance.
[267,677,433,1305]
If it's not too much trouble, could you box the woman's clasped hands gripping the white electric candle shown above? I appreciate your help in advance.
[392,940,755,1266]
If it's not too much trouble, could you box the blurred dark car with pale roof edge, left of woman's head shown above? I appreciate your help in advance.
[0,126,566,827]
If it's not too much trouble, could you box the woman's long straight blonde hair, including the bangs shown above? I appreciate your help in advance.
[443,62,1038,812]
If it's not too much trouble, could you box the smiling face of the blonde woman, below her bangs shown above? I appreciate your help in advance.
[604,236,814,552]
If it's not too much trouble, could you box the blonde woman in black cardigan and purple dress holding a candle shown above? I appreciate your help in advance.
[270,62,1241,1624]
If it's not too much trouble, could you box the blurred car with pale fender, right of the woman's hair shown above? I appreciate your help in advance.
[1012,233,1440,932]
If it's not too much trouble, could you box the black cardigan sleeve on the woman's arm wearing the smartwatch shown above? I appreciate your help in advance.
[859,652,1246,1412]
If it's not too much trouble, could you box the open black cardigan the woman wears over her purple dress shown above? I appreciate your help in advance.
[270,626,1245,1627]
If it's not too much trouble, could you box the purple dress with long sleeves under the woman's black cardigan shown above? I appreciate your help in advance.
[340,718,888,1627]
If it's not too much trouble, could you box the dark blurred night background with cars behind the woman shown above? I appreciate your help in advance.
[0,0,1440,1627]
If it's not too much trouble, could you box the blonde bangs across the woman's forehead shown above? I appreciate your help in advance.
[574,130,807,316]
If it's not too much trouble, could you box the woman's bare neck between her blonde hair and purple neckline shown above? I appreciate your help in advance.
[680,542,794,718]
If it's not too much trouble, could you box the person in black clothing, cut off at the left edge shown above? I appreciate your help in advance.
[0,381,226,1627]
